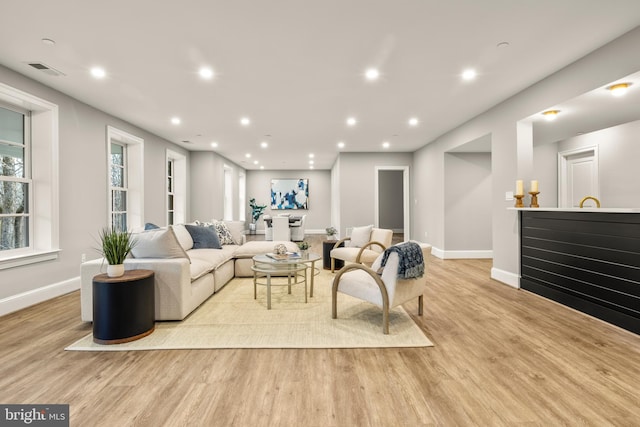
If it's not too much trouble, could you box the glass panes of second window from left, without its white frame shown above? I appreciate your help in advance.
[109,142,128,231]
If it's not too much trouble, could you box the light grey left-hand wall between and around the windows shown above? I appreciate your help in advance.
[0,61,189,314]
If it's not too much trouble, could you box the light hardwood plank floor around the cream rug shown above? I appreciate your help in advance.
[0,246,640,426]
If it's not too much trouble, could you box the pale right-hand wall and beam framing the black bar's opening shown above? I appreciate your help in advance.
[412,27,640,286]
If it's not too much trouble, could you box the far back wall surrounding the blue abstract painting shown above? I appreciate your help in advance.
[247,170,332,233]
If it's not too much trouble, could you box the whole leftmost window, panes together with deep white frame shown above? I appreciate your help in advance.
[0,83,59,269]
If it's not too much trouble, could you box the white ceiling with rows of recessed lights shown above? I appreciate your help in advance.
[0,0,640,169]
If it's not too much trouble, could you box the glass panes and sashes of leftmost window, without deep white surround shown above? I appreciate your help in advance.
[0,107,33,251]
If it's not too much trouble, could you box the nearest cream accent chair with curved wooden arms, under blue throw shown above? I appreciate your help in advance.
[331,244,431,334]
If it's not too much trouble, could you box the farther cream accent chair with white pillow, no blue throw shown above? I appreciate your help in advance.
[330,226,393,273]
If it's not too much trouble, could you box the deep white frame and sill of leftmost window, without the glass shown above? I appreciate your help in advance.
[0,83,60,270]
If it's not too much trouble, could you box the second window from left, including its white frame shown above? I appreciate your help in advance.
[107,126,144,231]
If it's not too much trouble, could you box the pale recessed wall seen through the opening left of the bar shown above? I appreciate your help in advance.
[442,153,492,254]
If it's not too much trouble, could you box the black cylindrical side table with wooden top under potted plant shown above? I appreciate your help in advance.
[93,270,155,344]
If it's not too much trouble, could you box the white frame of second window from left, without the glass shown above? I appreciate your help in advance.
[106,126,144,231]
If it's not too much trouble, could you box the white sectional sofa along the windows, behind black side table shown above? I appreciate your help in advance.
[80,221,297,322]
